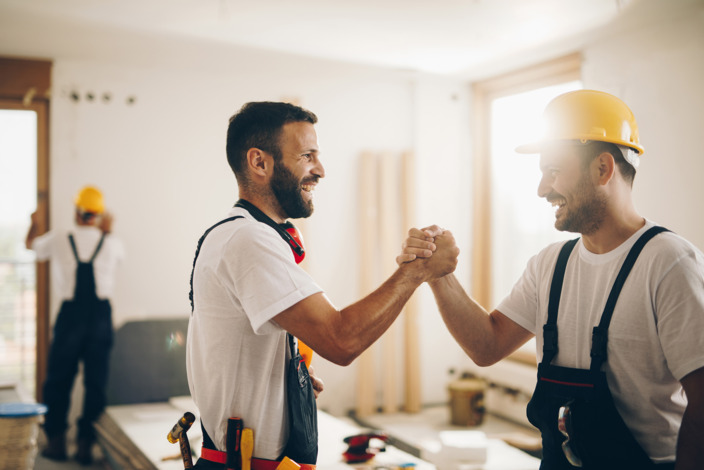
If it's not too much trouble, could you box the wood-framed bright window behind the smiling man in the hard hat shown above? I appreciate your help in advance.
[472,54,582,363]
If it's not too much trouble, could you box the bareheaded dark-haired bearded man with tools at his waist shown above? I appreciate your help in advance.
[187,102,459,470]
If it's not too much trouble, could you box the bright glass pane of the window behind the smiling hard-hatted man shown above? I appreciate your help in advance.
[491,81,582,308]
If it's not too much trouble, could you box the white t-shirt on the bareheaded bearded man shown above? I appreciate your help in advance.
[186,207,322,459]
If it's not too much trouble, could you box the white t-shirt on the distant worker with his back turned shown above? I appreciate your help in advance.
[32,225,125,300]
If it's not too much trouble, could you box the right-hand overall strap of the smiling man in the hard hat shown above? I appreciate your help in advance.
[590,226,669,370]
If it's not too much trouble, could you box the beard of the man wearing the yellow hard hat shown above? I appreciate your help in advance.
[547,175,606,235]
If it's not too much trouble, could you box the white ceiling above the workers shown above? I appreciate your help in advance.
[0,0,639,75]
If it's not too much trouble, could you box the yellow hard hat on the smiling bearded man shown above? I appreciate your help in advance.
[516,90,644,155]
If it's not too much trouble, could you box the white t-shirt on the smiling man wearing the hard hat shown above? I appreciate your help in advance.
[497,221,704,462]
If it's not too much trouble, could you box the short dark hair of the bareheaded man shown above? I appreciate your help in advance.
[226,101,318,183]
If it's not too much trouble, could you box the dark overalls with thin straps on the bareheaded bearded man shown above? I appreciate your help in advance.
[189,199,318,469]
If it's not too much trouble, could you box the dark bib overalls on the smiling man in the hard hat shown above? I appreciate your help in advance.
[527,227,674,470]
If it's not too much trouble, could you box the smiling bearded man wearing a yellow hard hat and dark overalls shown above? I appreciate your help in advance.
[397,90,704,470]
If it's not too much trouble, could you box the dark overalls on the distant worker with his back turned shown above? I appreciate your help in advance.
[43,234,113,441]
